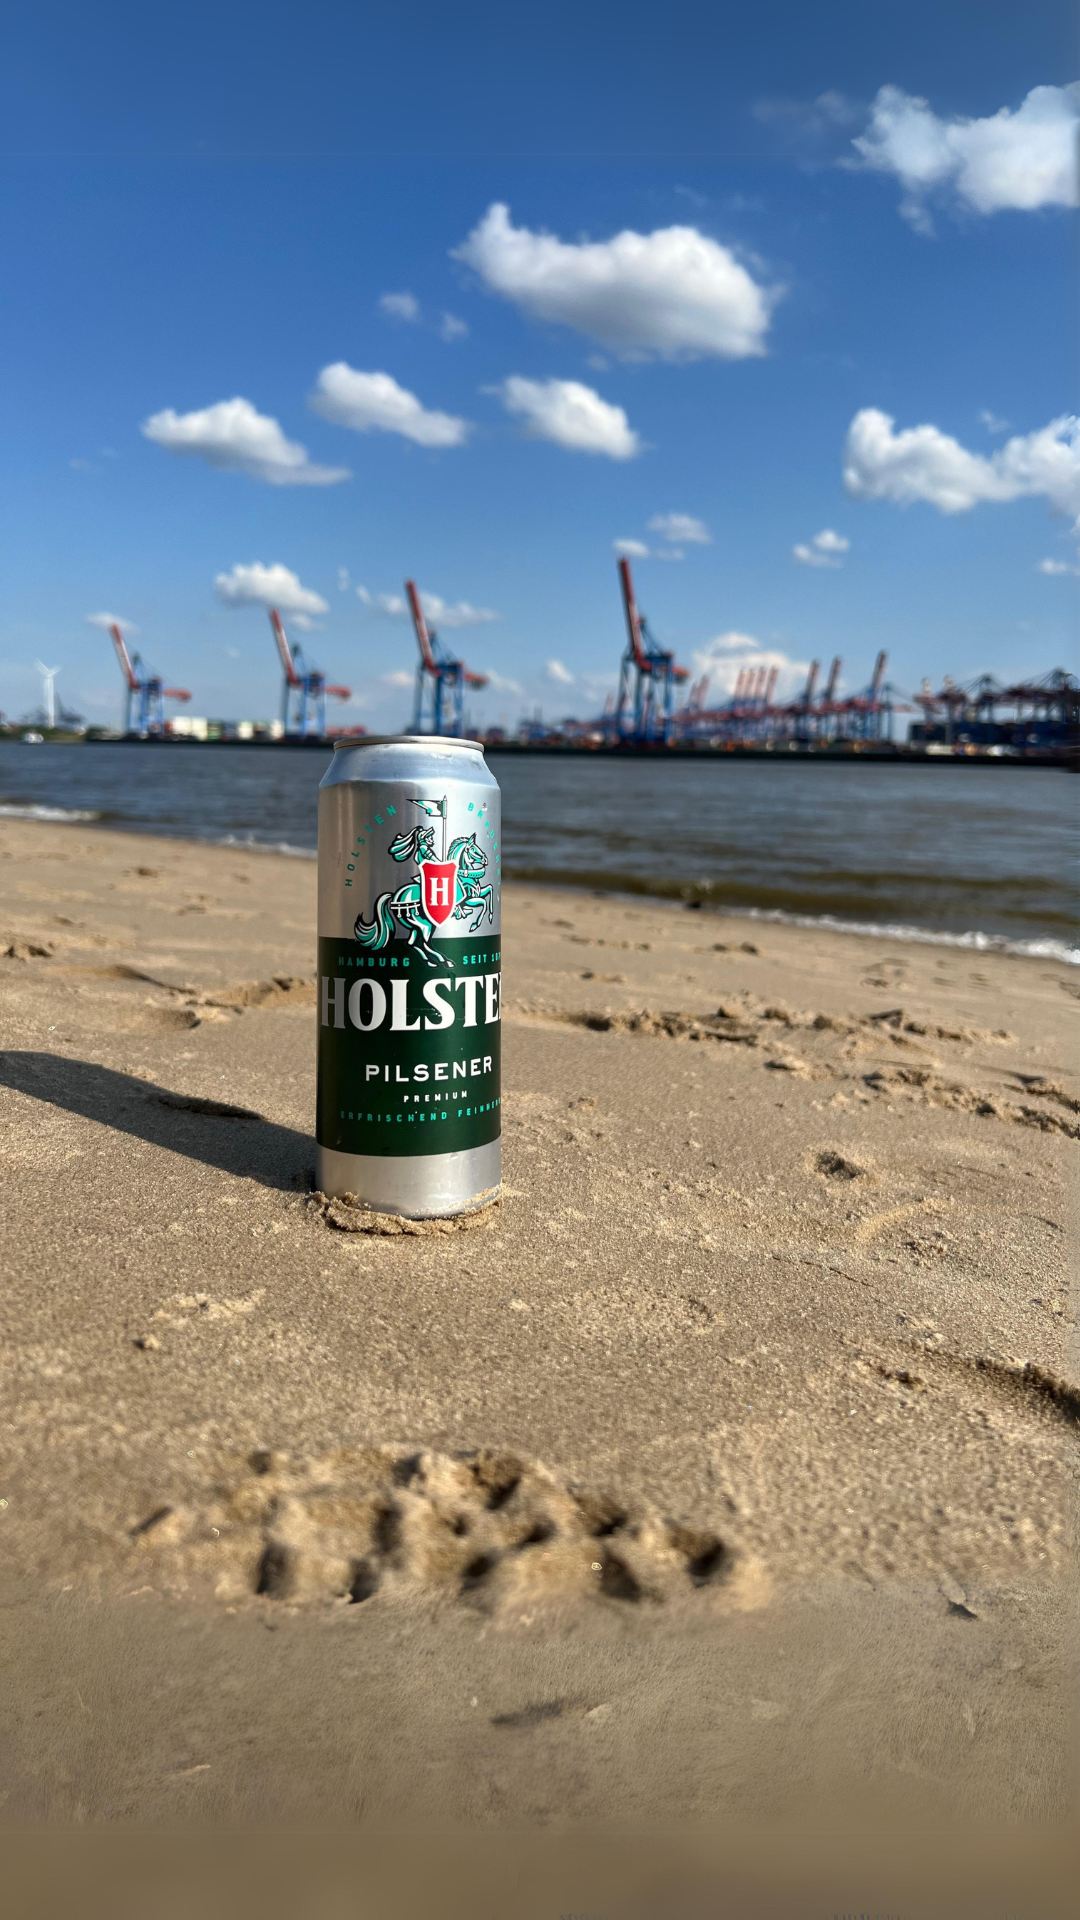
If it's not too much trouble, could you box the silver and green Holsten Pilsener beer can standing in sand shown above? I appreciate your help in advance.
[315,733,502,1219]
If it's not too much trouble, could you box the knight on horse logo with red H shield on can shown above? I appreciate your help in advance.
[354,795,494,966]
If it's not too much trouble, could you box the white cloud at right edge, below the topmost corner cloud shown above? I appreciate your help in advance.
[844,407,1080,515]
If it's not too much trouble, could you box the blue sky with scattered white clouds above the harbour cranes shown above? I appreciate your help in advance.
[0,0,1080,728]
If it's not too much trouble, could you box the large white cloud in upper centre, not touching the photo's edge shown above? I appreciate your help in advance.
[454,202,776,361]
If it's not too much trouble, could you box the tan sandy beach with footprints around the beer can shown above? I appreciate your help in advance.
[0,820,1080,1824]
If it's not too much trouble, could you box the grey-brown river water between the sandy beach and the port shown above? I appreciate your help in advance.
[0,741,1080,964]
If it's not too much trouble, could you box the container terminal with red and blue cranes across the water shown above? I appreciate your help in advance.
[0,557,1080,768]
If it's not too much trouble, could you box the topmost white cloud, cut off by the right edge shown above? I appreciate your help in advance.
[853,84,1080,232]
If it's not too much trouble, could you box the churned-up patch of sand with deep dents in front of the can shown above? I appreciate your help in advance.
[119,1448,749,1617]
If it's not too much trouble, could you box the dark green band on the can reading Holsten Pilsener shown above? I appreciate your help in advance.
[315,933,502,1158]
